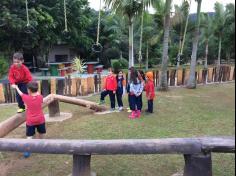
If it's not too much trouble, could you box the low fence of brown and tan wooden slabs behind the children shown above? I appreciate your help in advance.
[0,65,235,103]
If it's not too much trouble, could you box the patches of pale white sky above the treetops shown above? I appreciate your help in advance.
[88,0,235,13]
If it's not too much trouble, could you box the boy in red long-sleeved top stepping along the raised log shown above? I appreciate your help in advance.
[8,53,32,113]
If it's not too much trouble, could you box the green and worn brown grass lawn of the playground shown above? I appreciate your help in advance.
[0,83,235,176]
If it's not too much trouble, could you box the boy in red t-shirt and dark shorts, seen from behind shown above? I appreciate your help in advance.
[12,82,46,158]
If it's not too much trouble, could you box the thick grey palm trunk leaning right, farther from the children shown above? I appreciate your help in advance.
[187,0,202,89]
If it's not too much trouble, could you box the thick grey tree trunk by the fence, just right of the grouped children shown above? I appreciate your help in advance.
[160,0,172,91]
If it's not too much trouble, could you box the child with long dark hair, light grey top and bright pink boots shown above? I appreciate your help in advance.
[129,70,143,119]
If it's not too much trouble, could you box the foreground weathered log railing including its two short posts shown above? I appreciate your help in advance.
[0,137,235,176]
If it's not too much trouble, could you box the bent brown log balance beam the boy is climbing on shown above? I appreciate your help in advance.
[0,94,107,138]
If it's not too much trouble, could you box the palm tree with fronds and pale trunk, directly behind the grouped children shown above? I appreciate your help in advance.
[105,0,152,67]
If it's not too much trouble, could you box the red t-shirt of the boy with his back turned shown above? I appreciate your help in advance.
[22,94,45,126]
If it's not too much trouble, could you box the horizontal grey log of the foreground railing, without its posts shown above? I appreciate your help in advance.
[0,137,235,155]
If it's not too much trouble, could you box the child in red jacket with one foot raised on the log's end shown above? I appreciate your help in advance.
[100,68,117,111]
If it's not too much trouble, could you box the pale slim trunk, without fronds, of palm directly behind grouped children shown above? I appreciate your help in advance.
[129,18,134,67]
